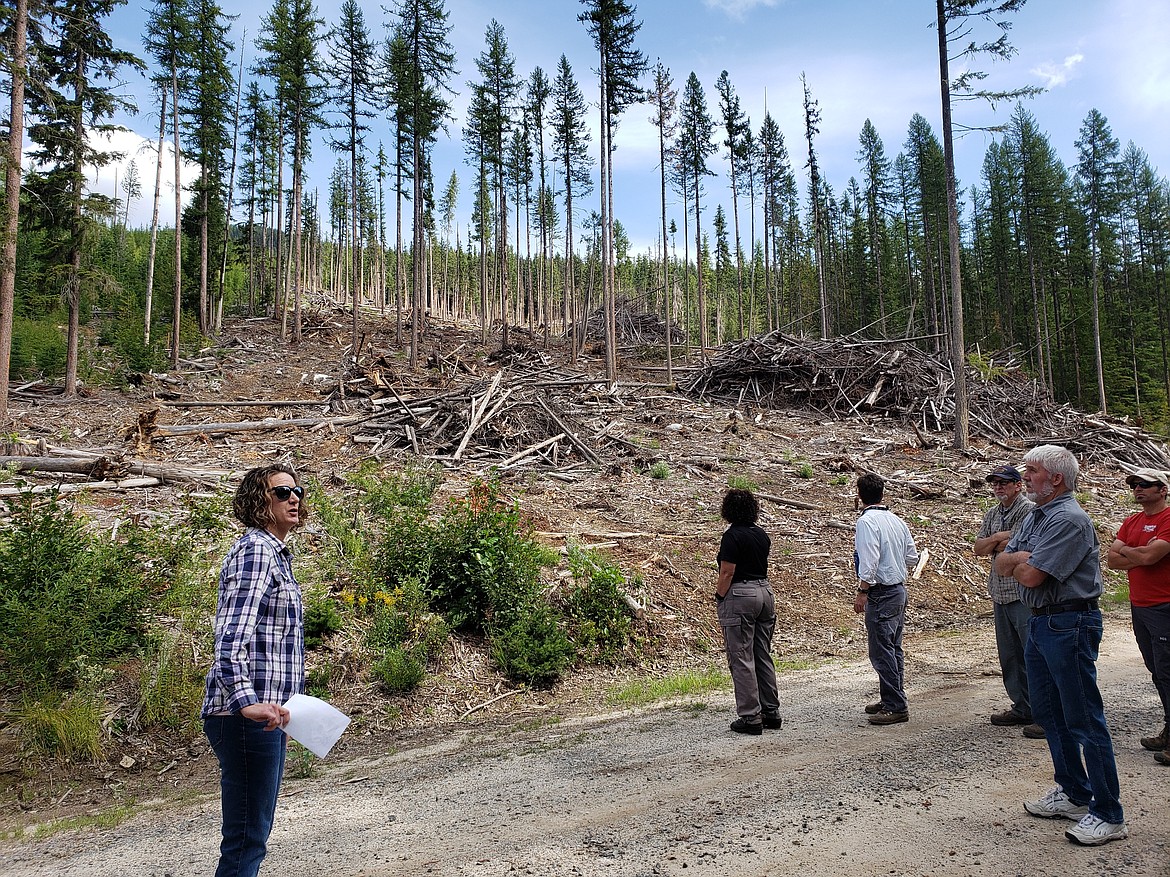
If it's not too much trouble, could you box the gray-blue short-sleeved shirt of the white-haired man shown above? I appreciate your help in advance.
[1004,493,1104,608]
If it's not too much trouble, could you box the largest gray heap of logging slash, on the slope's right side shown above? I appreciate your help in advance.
[680,332,1170,469]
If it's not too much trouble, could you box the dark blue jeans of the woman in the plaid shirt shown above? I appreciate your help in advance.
[204,714,288,877]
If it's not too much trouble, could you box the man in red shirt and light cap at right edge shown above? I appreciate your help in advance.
[1107,469,1170,765]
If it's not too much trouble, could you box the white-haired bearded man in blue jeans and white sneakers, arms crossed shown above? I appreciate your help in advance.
[996,444,1129,847]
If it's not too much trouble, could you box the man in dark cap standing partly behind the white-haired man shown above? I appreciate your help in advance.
[975,464,1044,738]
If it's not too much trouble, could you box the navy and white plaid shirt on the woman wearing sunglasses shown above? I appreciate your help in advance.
[202,529,304,716]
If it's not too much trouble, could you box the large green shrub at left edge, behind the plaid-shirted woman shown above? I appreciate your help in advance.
[0,493,147,692]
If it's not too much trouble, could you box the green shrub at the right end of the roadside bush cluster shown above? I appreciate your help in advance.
[564,545,633,663]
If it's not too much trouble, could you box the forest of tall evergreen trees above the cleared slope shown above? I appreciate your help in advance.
[0,0,1170,433]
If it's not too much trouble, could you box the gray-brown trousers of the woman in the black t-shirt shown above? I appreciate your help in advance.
[718,580,780,723]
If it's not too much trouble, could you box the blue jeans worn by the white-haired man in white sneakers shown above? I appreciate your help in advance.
[1025,609,1124,822]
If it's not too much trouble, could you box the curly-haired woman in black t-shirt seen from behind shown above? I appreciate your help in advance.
[715,489,783,734]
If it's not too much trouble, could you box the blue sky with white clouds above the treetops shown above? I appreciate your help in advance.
[97,0,1170,257]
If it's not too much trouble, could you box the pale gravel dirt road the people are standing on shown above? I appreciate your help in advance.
[0,612,1170,877]
